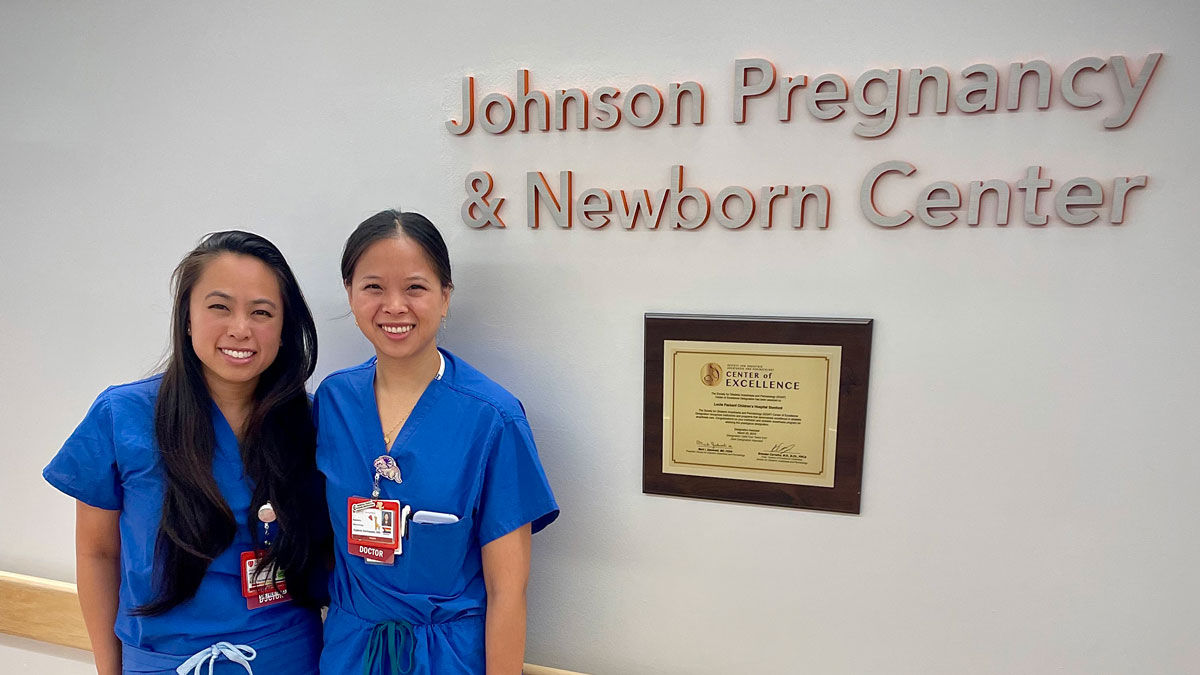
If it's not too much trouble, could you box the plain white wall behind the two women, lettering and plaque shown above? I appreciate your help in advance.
[0,0,1200,675]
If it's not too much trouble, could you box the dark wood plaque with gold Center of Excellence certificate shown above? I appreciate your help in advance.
[642,313,872,513]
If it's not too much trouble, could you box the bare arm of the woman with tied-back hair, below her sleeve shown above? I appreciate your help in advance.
[482,524,532,675]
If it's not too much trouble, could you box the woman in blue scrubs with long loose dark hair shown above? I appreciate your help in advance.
[43,231,330,675]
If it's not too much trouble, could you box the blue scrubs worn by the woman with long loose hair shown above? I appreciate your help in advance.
[42,376,320,675]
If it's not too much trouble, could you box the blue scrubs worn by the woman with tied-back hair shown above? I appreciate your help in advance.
[314,351,558,675]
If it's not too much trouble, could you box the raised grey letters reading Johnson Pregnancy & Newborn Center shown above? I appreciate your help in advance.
[445,53,1163,231]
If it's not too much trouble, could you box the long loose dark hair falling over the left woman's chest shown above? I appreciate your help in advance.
[134,231,332,615]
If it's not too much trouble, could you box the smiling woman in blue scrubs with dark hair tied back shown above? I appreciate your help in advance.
[314,211,558,675]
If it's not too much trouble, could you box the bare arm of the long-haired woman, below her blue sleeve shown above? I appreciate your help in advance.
[76,501,121,675]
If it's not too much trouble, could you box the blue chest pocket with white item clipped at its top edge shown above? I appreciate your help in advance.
[403,516,474,596]
